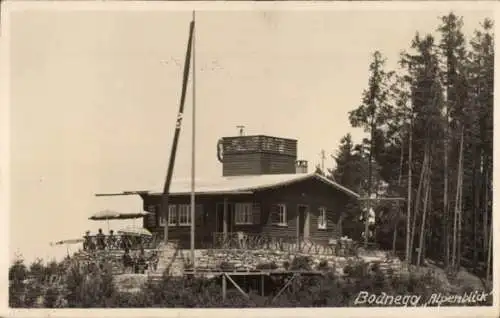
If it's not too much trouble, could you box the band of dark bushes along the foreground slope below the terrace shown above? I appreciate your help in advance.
[9,253,492,308]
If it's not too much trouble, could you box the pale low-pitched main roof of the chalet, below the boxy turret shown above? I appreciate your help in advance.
[96,173,359,198]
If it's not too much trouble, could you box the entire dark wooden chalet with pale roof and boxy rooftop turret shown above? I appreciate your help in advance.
[110,135,359,248]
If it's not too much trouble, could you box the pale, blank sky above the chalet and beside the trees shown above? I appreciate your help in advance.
[3,5,492,260]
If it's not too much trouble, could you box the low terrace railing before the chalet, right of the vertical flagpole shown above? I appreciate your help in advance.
[212,232,357,256]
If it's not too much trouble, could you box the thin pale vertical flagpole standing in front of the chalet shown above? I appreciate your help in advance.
[191,11,196,271]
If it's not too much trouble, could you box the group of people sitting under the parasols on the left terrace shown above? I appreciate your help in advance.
[83,229,143,251]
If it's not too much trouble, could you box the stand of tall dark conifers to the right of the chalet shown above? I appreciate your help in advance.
[332,13,494,276]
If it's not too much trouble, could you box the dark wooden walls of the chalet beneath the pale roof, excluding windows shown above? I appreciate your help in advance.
[142,177,356,248]
